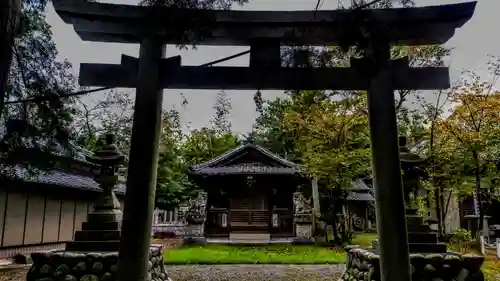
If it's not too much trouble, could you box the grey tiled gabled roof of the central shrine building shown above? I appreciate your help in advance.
[189,143,300,175]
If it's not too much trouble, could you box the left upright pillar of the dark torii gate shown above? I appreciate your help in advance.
[117,38,165,281]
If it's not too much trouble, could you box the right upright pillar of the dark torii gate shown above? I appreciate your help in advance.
[367,37,411,281]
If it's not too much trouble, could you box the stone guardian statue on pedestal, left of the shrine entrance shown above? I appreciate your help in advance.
[184,191,207,244]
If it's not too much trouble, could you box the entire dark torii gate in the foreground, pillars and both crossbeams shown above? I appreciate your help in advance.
[53,0,476,281]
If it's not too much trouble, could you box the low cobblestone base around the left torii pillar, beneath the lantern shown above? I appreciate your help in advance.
[26,245,171,281]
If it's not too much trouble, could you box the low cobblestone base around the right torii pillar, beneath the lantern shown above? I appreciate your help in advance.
[341,246,484,281]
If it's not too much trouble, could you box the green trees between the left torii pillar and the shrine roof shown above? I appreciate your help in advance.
[156,92,239,209]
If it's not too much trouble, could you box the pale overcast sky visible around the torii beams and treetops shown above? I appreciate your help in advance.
[46,0,500,133]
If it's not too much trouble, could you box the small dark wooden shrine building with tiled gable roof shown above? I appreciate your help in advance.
[190,143,308,238]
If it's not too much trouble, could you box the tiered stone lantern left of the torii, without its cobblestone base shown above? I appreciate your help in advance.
[67,134,125,251]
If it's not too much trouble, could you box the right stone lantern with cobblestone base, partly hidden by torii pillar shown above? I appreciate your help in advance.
[342,137,484,281]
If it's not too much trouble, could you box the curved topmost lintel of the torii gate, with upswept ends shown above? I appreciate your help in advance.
[52,0,477,46]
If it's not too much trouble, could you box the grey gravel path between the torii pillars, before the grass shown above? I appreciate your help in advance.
[166,265,344,281]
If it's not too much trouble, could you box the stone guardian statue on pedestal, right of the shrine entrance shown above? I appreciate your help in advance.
[293,192,314,244]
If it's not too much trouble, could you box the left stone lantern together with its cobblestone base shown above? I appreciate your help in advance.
[27,134,170,281]
